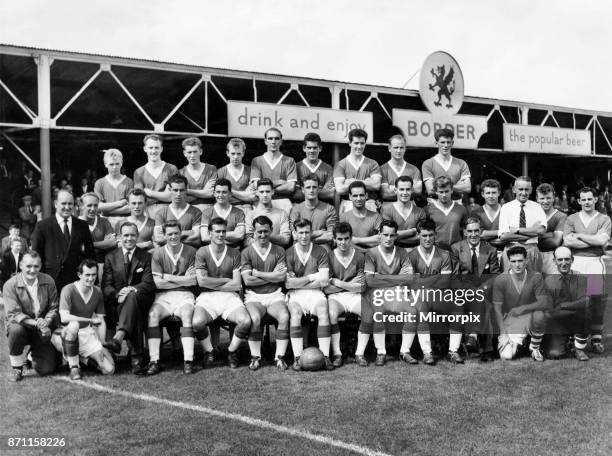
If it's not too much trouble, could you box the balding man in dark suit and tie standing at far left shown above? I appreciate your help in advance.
[32,190,94,290]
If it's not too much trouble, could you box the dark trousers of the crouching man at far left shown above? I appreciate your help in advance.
[7,323,58,375]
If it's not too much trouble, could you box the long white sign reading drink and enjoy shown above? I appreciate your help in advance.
[227,101,374,143]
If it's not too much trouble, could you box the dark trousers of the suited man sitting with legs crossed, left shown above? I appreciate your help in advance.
[115,292,154,355]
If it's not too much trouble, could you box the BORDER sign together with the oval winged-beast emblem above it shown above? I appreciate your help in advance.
[393,51,487,149]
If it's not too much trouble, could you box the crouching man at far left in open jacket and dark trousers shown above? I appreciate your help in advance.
[3,250,59,382]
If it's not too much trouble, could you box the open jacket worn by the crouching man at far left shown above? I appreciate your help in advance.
[2,273,59,330]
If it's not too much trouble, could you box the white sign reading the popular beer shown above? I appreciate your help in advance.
[504,124,591,155]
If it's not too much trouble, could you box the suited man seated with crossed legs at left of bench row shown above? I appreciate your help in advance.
[102,222,155,375]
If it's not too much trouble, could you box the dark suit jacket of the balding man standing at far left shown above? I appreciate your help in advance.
[32,215,95,290]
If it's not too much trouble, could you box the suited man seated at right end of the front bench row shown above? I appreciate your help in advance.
[451,217,501,361]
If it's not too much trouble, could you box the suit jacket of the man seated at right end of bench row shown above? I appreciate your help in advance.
[451,240,501,282]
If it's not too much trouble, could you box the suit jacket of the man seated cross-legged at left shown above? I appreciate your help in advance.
[102,247,155,299]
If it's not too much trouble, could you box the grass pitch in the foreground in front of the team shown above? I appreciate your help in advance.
[0,318,612,456]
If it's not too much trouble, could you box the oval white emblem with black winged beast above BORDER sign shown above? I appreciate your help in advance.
[419,51,463,116]
